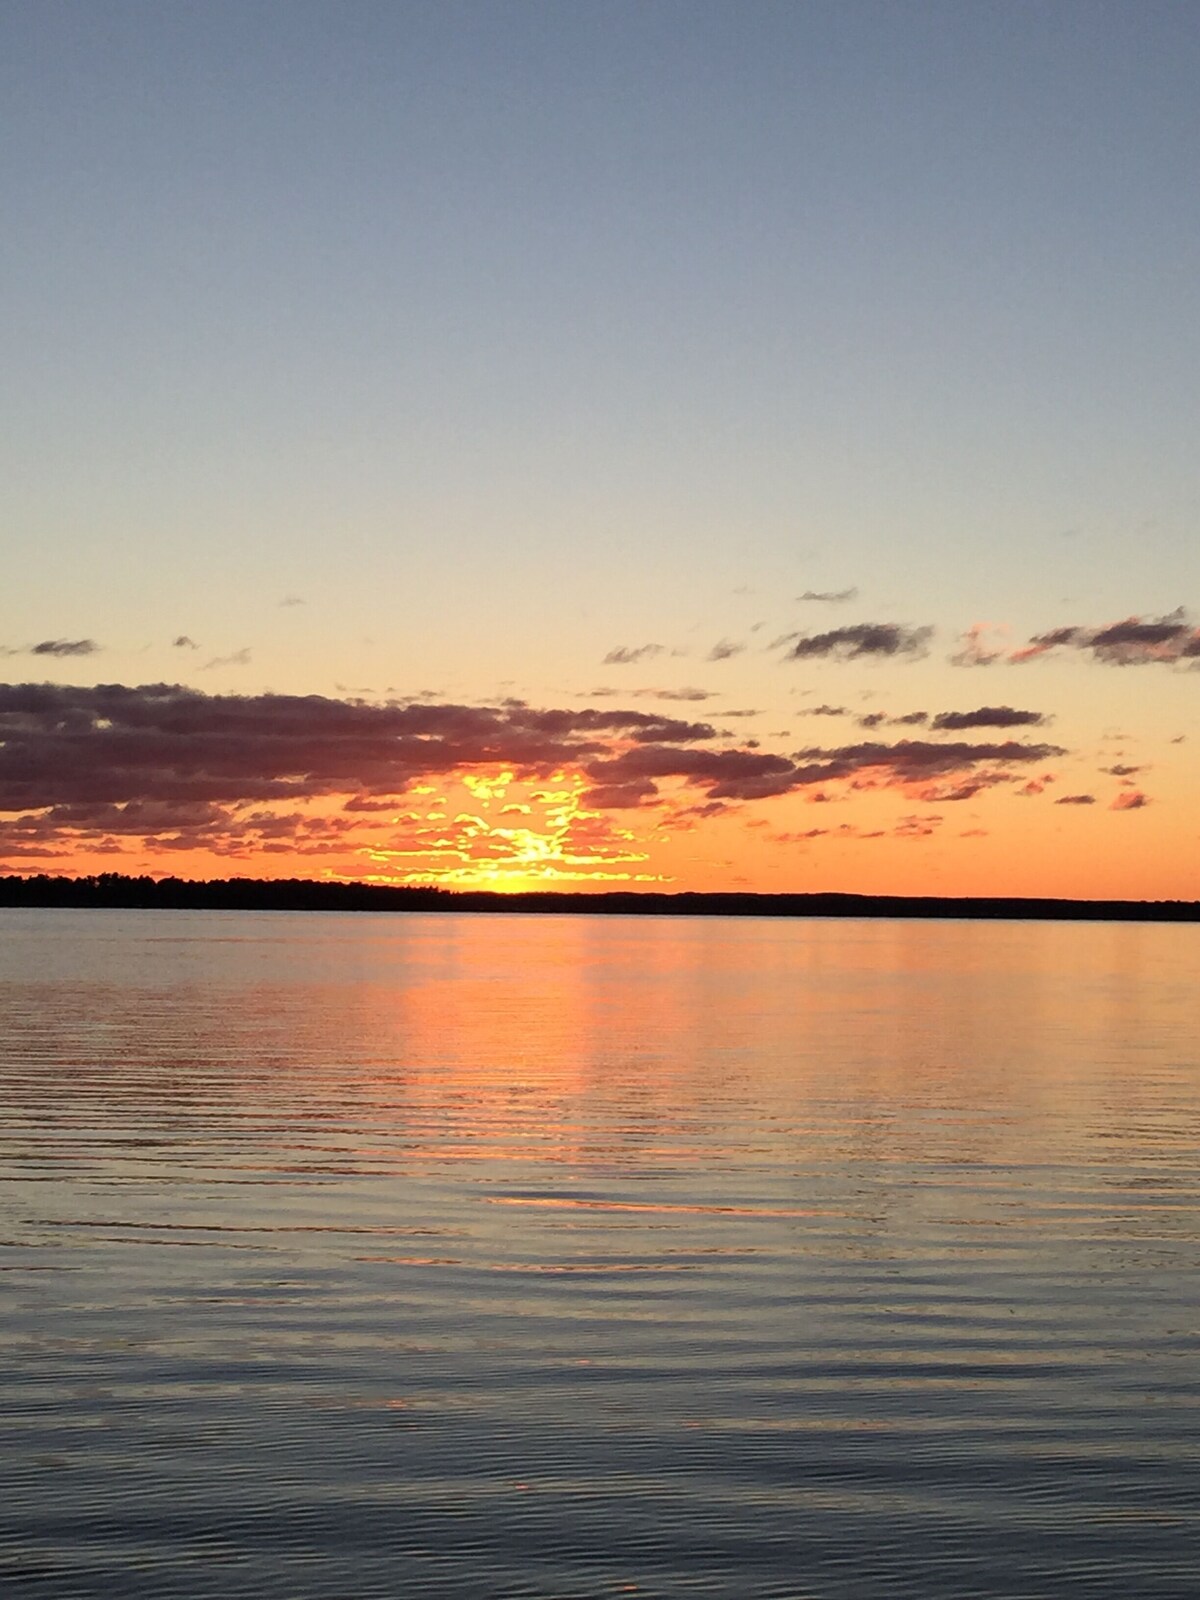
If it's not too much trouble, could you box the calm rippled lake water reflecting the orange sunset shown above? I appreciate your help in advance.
[0,910,1200,1600]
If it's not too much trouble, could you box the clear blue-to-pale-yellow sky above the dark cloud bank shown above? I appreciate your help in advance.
[0,0,1200,896]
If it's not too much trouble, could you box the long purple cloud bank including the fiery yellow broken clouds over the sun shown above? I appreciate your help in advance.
[0,683,1081,882]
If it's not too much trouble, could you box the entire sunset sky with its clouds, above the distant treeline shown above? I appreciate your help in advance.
[0,0,1200,899]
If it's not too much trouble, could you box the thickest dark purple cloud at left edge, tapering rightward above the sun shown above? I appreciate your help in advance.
[0,683,717,816]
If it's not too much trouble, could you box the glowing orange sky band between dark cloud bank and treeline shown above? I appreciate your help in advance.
[0,736,1200,899]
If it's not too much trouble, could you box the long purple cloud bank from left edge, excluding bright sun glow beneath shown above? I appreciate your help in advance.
[0,683,1068,854]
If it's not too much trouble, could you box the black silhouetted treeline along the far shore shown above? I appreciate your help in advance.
[0,872,1200,922]
